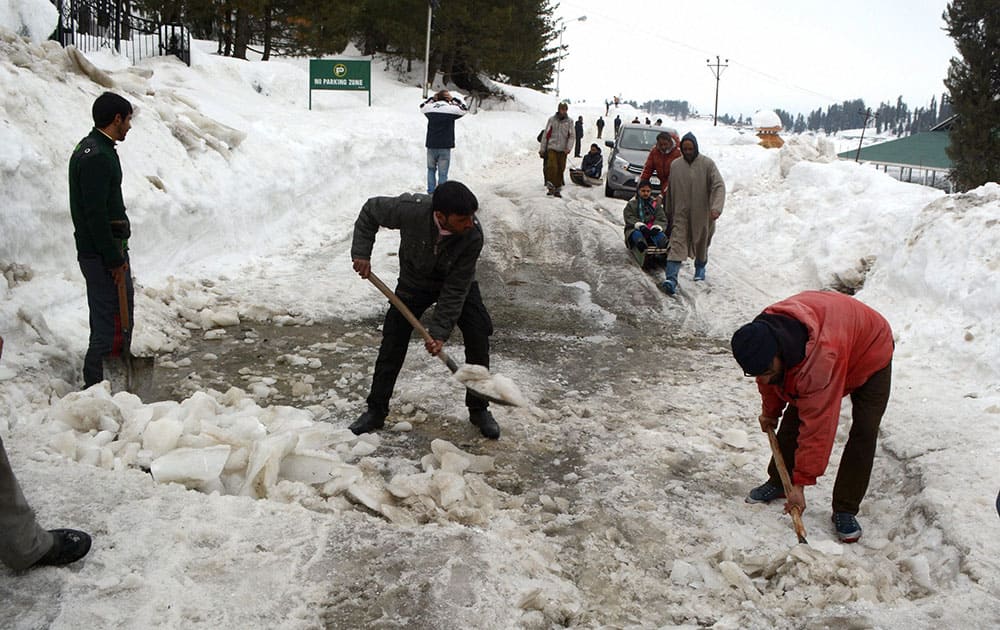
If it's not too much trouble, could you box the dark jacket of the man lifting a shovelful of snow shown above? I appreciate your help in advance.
[351,194,483,341]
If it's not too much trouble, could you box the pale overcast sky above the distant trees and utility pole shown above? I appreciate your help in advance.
[556,0,957,116]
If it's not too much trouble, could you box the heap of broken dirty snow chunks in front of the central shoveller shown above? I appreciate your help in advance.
[47,384,508,525]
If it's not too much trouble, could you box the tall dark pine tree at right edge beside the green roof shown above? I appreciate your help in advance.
[942,0,1000,190]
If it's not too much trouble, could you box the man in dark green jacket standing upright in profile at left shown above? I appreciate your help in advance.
[69,92,133,387]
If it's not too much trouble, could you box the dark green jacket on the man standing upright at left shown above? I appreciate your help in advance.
[69,128,129,269]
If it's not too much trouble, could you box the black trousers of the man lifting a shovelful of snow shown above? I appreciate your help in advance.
[368,282,493,416]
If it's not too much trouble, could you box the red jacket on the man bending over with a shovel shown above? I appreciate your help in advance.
[757,291,893,486]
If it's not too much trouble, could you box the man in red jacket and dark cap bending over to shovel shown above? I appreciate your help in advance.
[731,291,893,543]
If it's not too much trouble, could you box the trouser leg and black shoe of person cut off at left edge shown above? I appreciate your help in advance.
[0,337,91,571]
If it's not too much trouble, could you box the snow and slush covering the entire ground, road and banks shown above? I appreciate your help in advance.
[0,11,1000,629]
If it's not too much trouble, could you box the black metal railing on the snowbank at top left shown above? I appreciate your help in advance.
[53,0,191,66]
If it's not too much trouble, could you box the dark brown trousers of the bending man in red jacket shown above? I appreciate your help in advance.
[767,361,892,514]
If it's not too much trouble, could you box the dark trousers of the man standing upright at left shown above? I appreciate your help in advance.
[77,254,135,387]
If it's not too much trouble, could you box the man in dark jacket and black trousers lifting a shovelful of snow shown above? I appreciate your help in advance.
[351,181,500,440]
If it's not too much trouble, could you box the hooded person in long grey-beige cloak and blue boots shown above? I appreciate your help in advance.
[663,132,726,295]
